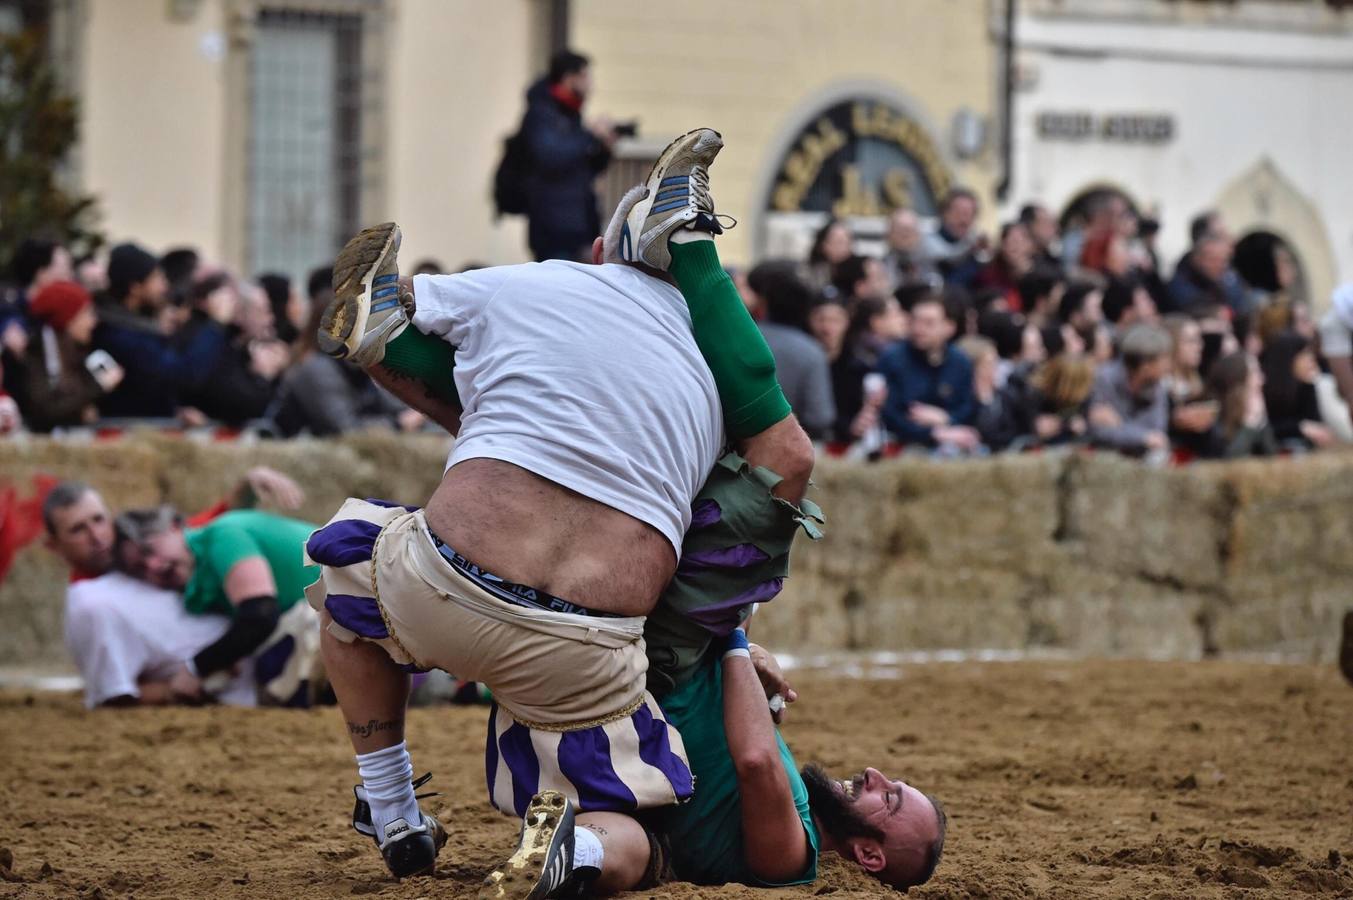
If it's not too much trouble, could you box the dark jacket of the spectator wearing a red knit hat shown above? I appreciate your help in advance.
[5,328,103,432]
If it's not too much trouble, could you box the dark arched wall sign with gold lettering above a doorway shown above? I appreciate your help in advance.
[770,100,953,218]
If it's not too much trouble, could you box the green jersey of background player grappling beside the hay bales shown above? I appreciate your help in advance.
[183,509,319,616]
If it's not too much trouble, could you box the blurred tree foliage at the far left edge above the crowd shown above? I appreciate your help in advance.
[0,26,103,277]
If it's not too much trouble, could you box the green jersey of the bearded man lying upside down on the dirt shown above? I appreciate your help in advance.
[653,654,819,888]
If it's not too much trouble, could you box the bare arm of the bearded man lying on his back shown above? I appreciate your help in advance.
[721,629,809,882]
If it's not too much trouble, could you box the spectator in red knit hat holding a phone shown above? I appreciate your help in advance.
[15,282,123,432]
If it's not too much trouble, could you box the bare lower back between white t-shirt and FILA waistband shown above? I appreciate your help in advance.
[426,459,677,616]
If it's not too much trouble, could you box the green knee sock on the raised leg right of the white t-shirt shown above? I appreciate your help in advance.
[670,241,790,440]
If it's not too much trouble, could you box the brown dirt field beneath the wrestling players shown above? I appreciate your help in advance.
[0,662,1353,900]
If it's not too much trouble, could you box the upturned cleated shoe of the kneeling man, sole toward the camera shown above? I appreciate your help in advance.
[479,790,589,900]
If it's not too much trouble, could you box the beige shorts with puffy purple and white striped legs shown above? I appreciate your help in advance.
[306,499,693,815]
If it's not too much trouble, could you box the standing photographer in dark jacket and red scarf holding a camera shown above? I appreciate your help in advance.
[521,50,617,261]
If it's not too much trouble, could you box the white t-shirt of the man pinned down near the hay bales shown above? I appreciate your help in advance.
[66,572,257,709]
